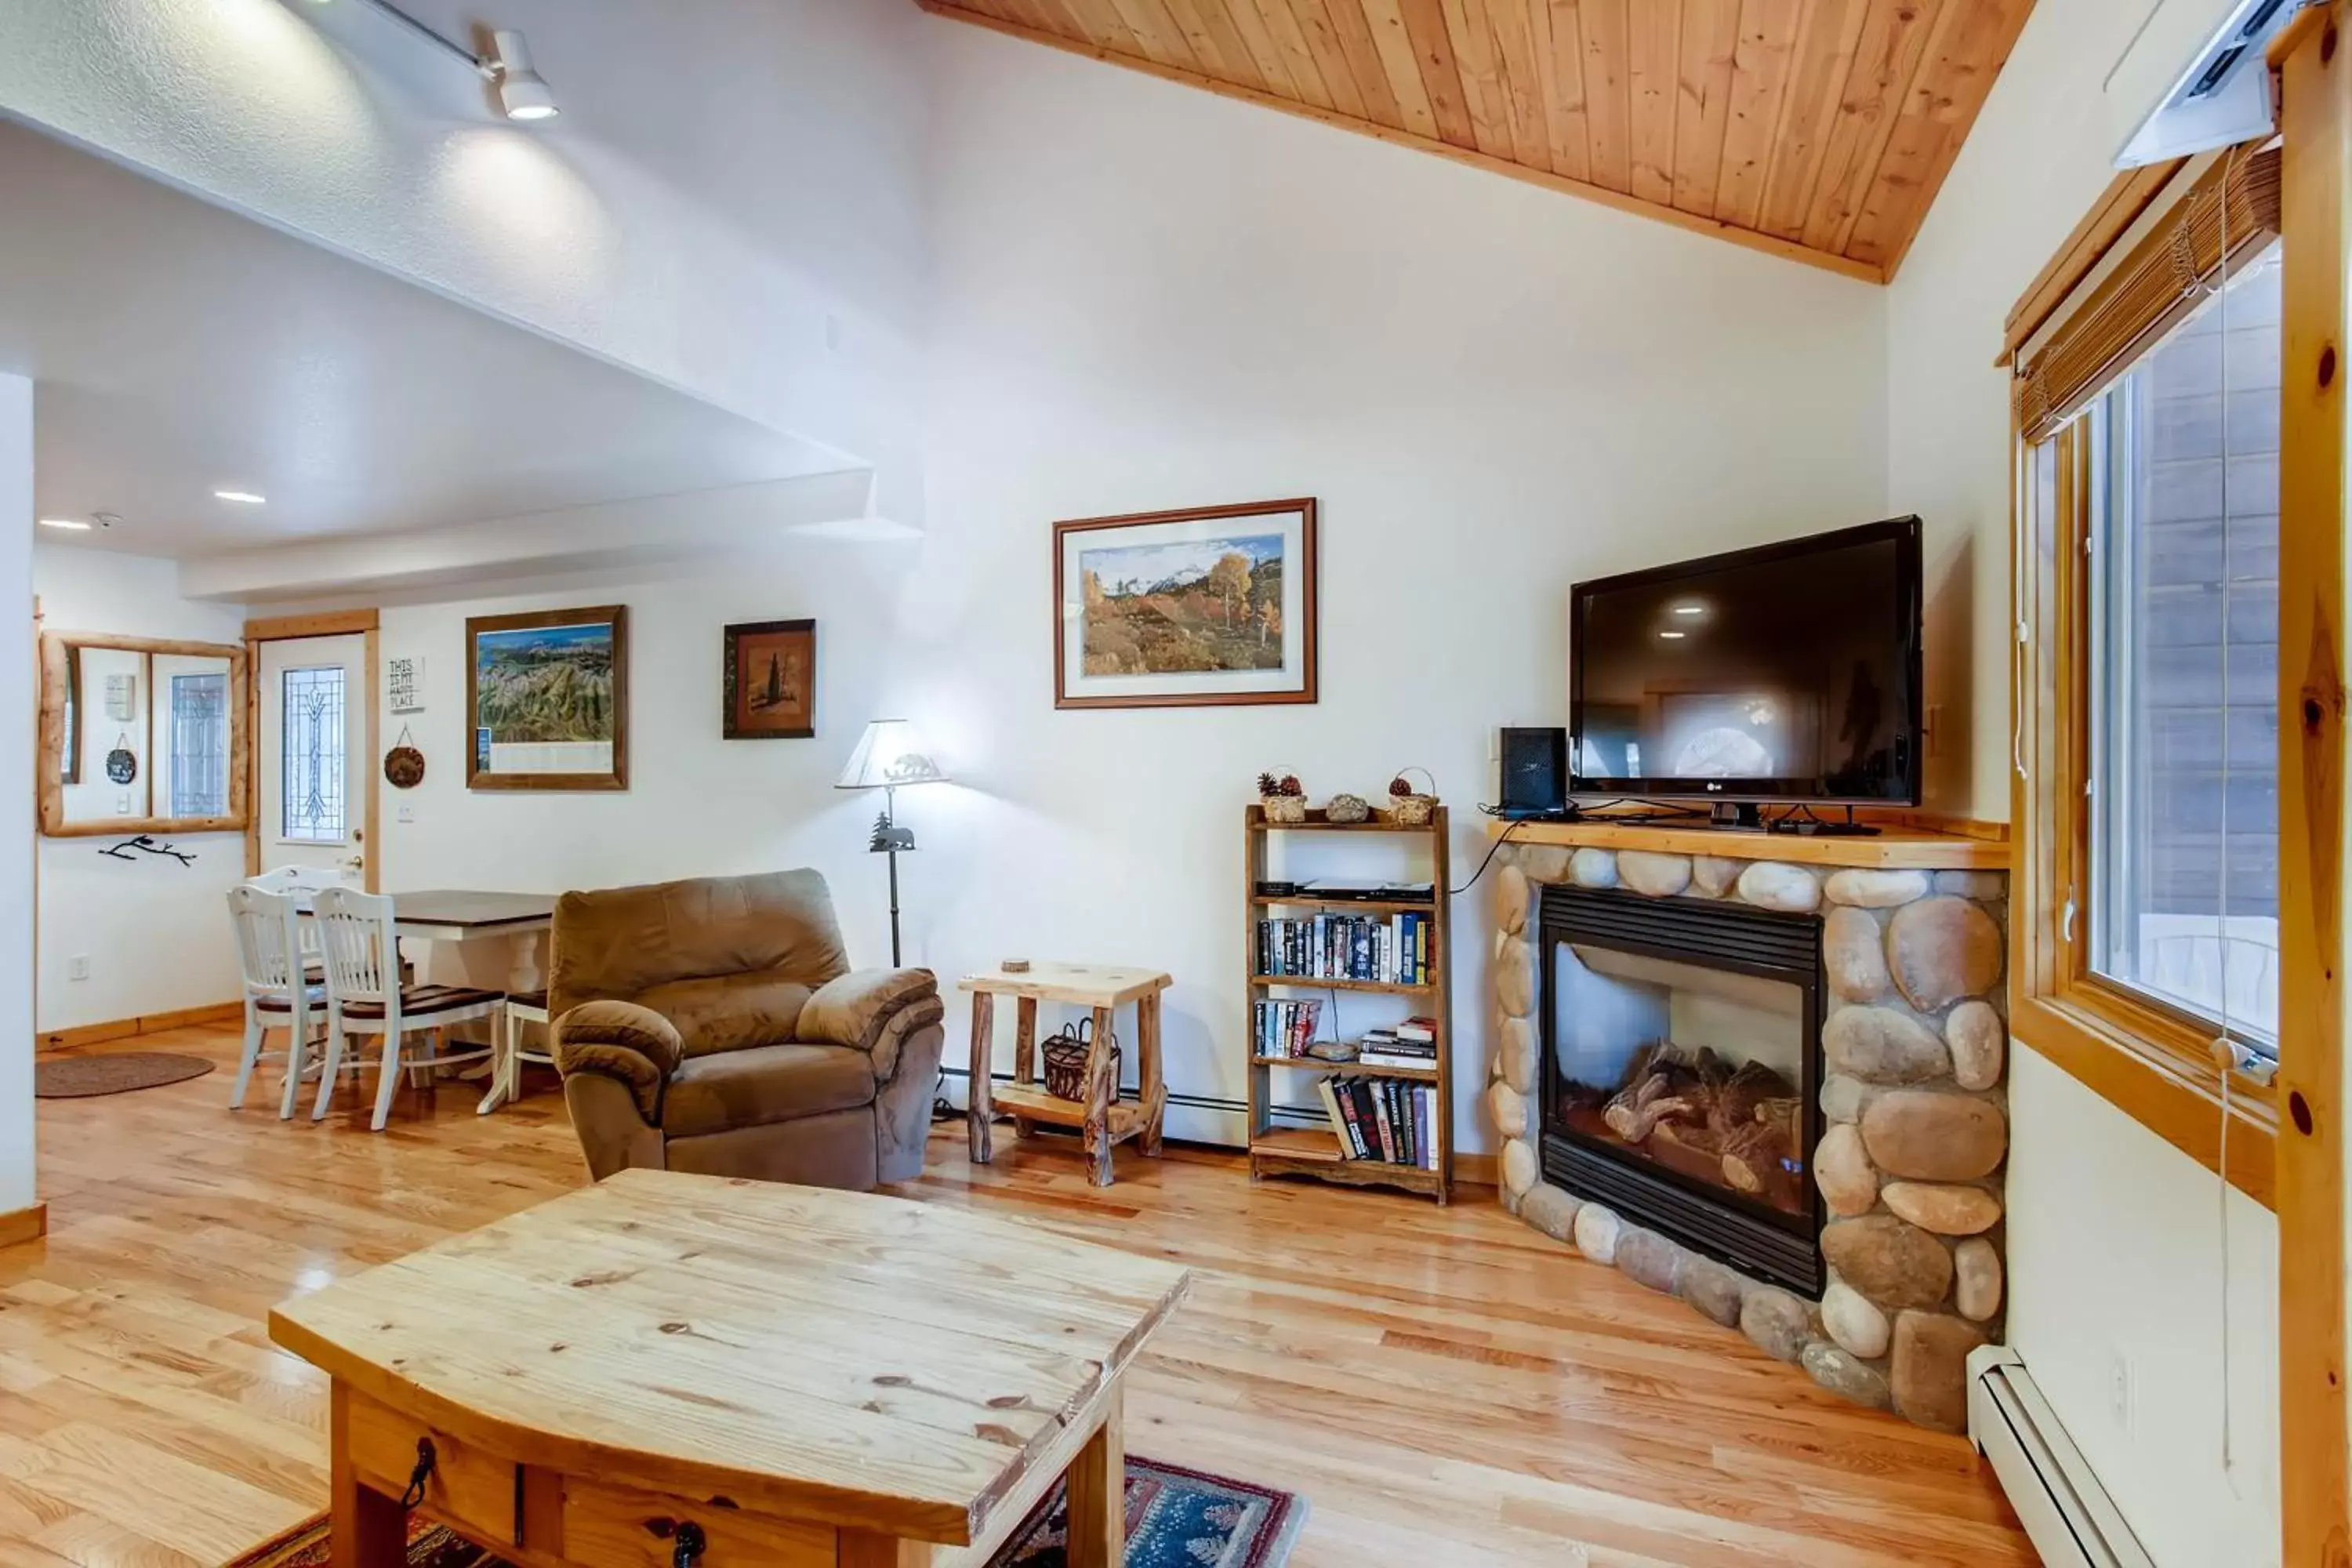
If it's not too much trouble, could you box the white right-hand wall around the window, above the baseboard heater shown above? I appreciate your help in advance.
[1886,0,2279,1568]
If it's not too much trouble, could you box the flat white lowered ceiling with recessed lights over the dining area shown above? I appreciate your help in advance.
[0,120,854,560]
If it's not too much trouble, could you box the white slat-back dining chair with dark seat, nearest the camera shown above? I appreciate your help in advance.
[310,886,506,1133]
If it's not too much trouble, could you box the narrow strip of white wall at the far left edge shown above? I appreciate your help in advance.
[0,376,35,1213]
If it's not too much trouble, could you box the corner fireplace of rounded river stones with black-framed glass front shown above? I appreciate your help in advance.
[1486,825,2009,1429]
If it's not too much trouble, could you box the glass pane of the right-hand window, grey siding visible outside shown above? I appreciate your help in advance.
[2086,245,2279,1053]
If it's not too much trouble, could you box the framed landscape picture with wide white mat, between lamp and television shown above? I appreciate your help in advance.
[1054,501,1315,708]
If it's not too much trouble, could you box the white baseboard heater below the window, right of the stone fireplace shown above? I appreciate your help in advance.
[1969,1345,2157,1568]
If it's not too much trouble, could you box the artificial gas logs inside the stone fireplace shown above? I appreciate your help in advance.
[1559,1039,1804,1213]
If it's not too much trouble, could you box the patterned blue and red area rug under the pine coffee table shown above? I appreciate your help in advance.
[223,1457,1308,1568]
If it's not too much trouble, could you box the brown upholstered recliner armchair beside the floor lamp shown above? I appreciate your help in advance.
[548,869,946,1189]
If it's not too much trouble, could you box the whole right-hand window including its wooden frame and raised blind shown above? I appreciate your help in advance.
[2009,148,2284,1201]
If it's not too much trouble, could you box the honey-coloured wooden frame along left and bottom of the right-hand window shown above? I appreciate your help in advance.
[2009,248,2279,1208]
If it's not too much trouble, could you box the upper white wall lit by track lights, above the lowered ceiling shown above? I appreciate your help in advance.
[0,0,924,522]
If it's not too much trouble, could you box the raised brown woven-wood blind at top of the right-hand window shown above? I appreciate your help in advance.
[2016,148,2279,442]
